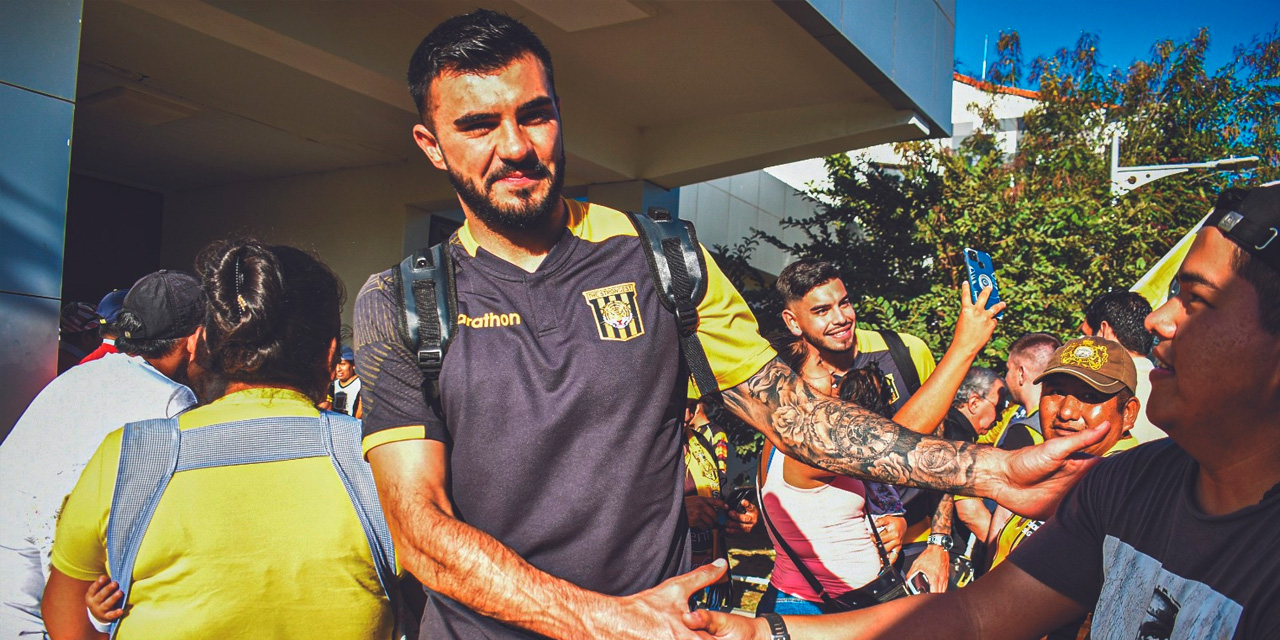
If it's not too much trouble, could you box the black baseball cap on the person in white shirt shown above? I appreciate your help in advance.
[120,269,205,340]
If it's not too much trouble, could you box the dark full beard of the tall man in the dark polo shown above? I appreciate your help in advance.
[445,151,564,232]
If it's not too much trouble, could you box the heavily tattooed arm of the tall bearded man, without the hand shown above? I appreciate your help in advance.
[724,358,1000,495]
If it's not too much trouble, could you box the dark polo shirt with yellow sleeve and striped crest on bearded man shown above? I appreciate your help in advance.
[355,201,774,637]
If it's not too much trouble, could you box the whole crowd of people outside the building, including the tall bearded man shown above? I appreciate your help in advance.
[0,5,1280,640]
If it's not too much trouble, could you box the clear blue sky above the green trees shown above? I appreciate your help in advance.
[955,0,1280,81]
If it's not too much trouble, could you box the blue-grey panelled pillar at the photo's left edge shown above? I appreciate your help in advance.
[0,0,82,438]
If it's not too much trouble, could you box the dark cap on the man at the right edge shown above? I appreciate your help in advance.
[1204,183,1280,271]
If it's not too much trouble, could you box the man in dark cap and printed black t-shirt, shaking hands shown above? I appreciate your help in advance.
[686,184,1280,640]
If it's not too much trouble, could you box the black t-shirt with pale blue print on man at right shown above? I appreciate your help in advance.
[1009,440,1280,640]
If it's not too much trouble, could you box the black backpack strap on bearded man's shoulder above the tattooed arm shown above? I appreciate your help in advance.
[626,207,719,399]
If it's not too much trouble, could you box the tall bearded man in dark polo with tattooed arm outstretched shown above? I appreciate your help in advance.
[355,10,1097,639]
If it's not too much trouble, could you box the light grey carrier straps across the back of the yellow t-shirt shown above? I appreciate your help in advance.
[106,411,401,637]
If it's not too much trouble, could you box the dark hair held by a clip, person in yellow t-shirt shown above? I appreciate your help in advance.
[196,239,344,402]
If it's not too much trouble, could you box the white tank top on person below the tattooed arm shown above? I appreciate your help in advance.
[760,449,881,602]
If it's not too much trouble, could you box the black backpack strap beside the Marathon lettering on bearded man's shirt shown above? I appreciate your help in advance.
[392,242,458,421]
